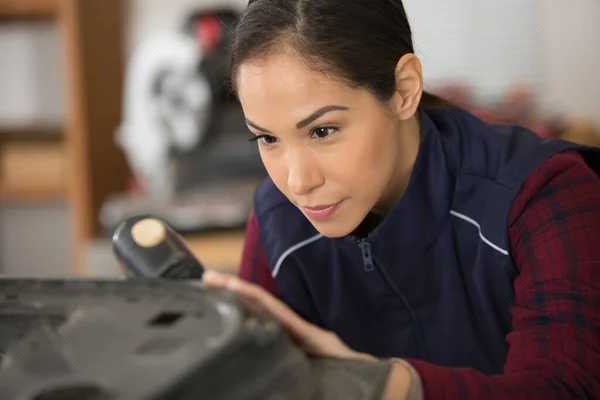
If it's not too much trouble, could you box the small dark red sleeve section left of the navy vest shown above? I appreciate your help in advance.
[238,212,279,297]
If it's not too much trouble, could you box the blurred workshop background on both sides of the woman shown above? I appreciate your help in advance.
[0,0,600,276]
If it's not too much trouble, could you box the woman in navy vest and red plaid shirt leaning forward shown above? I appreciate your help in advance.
[204,0,600,399]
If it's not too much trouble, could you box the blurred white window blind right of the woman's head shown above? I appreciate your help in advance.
[403,0,541,101]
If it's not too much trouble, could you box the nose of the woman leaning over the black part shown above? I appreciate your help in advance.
[287,152,325,196]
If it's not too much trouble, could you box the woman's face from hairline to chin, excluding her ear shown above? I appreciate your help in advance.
[237,53,410,237]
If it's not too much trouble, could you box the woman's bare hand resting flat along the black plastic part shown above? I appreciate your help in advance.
[202,270,376,360]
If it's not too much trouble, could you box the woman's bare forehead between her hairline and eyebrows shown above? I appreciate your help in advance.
[236,52,355,113]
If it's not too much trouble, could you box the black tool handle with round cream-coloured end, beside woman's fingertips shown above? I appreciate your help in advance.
[112,215,204,279]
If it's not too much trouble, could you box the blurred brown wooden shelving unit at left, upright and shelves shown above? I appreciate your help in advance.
[0,0,131,275]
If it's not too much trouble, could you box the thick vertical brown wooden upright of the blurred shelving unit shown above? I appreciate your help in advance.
[60,0,130,275]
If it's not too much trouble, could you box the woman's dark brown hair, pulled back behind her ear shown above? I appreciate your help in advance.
[229,0,447,107]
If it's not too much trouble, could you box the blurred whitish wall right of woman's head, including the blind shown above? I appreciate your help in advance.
[404,0,600,126]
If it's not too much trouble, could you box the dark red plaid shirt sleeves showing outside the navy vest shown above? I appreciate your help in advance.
[240,153,600,400]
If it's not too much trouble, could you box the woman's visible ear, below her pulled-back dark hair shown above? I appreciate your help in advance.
[391,54,423,120]
